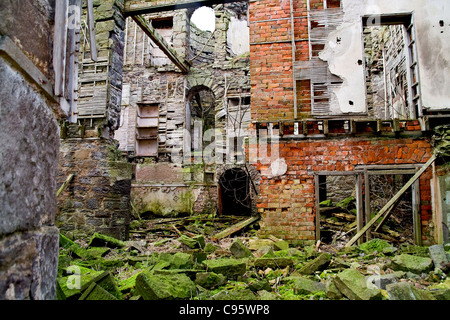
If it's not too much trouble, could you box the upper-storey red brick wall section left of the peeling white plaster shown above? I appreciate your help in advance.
[250,0,309,121]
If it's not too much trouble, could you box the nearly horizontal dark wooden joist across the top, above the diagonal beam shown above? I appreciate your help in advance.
[123,0,246,17]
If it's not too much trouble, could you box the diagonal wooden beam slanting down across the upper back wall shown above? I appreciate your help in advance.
[132,16,190,73]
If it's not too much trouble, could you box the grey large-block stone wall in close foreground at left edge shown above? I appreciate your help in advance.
[0,0,59,300]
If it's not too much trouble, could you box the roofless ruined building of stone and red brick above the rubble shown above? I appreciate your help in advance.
[0,0,450,299]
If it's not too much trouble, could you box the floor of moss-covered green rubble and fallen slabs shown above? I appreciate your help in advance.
[57,215,450,300]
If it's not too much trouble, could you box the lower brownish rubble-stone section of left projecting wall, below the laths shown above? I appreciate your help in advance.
[56,132,132,240]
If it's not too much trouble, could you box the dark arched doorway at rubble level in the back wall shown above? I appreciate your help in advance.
[219,168,251,216]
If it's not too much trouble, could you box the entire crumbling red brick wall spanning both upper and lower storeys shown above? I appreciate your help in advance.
[250,0,442,244]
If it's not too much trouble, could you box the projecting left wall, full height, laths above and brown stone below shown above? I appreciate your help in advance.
[56,0,132,239]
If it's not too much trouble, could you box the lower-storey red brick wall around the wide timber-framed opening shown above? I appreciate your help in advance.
[251,138,432,244]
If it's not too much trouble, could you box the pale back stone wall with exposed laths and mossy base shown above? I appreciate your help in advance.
[115,5,250,215]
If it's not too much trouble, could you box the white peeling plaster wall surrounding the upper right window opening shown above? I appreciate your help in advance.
[320,0,450,113]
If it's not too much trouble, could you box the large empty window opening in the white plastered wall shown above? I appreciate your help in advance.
[363,15,422,120]
